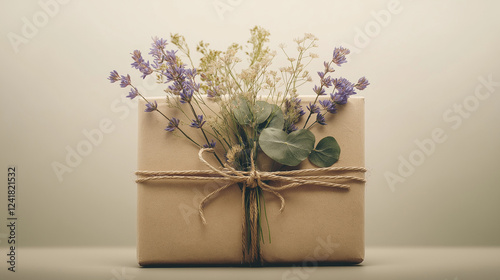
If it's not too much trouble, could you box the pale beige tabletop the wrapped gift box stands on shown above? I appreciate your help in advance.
[0,247,500,280]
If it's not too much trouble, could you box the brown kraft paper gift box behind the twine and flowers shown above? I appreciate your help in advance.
[137,96,365,266]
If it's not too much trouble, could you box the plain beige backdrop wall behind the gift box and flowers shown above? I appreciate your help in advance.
[0,0,500,253]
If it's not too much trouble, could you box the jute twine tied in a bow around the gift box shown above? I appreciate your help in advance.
[135,148,366,263]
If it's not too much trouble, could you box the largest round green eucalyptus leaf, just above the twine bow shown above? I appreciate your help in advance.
[259,127,315,166]
